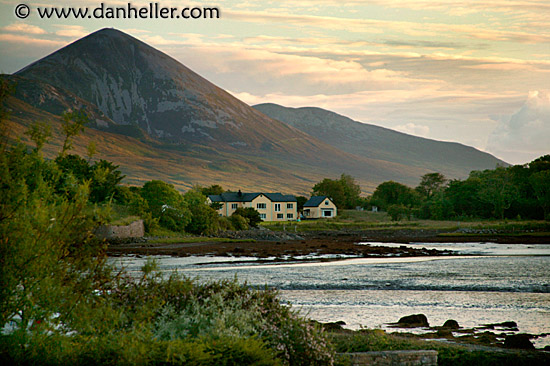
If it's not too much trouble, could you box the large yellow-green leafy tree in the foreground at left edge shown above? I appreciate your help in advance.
[0,144,110,339]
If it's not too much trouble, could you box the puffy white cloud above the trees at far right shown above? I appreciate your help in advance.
[487,91,550,164]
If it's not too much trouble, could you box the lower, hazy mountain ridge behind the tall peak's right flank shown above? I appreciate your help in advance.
[254,103,508,178]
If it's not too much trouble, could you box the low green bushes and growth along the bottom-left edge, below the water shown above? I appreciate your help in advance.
[0,263,333,365]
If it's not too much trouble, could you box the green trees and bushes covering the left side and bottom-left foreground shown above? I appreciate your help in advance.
[0,84,333,366]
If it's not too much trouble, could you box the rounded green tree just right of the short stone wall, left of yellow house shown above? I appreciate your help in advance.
[141,180,191,231]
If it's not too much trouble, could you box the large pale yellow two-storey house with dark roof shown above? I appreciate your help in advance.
[208,190,298,221]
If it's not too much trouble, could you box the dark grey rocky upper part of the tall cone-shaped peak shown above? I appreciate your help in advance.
[16,29,330,156]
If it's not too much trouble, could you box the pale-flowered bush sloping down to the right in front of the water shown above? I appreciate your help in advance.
[112,268,333,365]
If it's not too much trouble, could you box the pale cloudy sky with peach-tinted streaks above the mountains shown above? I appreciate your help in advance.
[0,0,550,163]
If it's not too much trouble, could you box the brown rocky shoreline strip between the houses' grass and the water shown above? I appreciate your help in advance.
[108,229,550,260]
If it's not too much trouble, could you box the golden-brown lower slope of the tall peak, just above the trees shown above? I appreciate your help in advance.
[2,96,312,194]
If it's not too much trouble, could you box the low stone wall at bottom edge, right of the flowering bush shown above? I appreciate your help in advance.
[338,351,437,366]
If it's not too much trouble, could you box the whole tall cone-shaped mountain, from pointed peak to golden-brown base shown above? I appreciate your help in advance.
[5,29,504,194]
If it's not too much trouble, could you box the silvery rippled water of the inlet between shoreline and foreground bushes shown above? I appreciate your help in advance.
[109,243,550,347]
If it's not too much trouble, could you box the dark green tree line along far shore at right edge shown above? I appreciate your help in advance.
[366,155,550,220]
